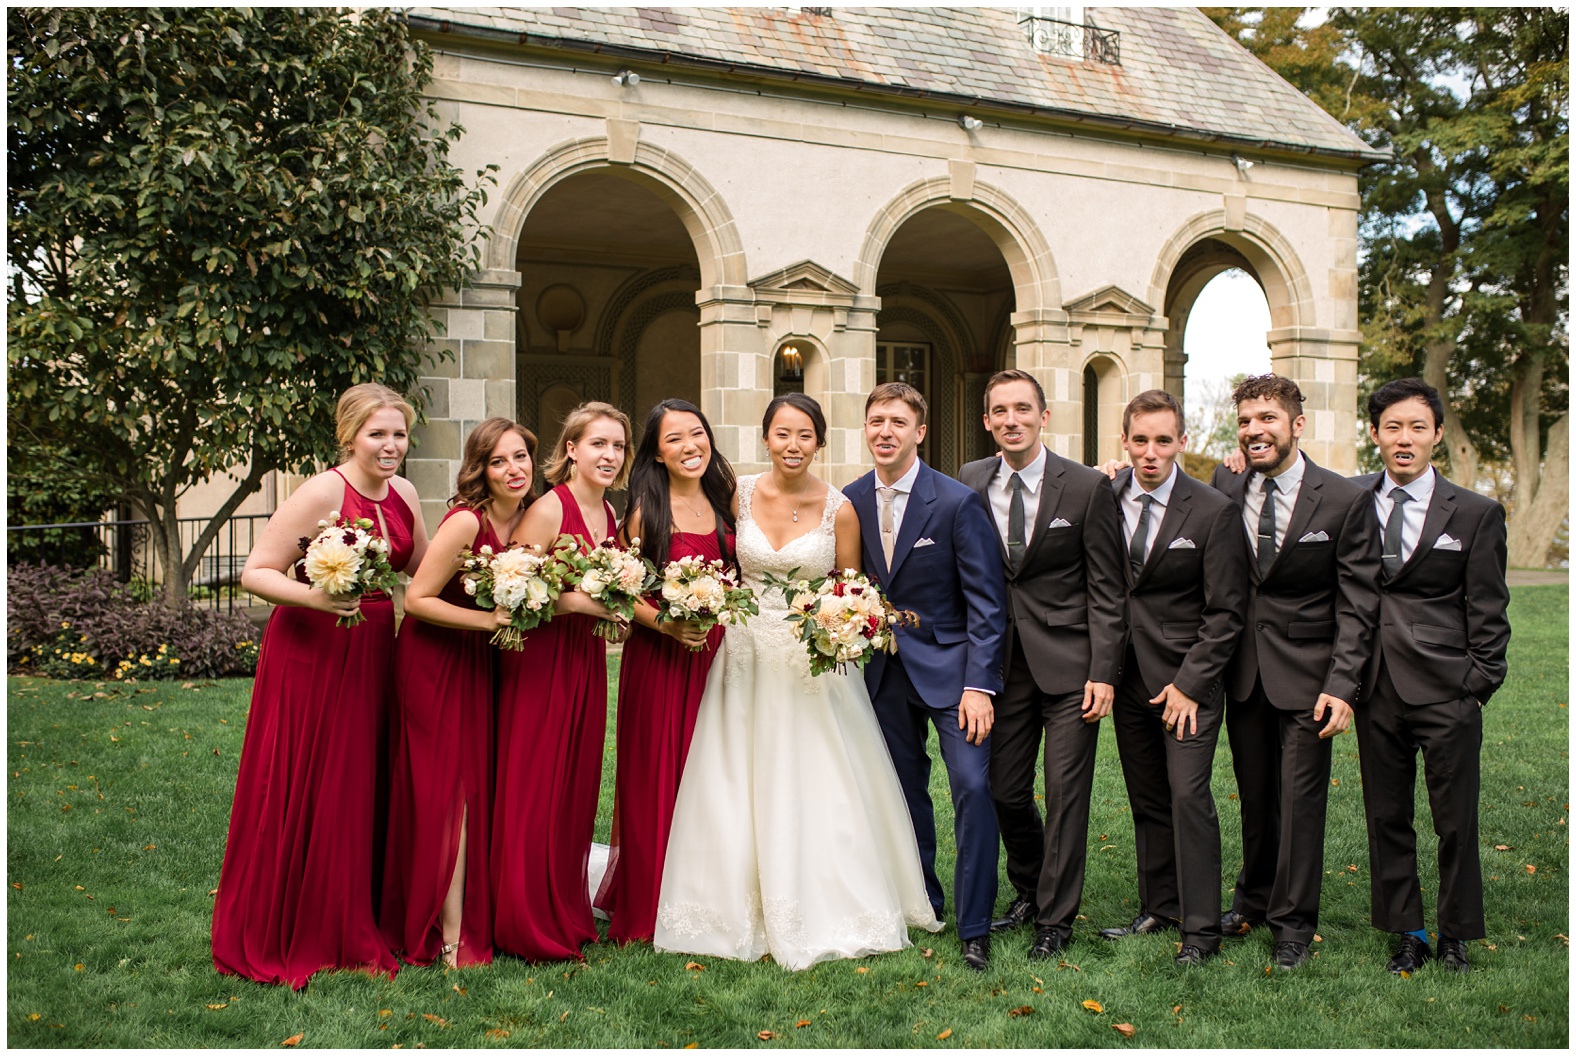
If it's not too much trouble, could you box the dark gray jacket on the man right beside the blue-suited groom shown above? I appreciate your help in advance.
[958,449,1127,695]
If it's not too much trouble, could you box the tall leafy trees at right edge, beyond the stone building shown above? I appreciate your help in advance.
[1207,8,1570,566]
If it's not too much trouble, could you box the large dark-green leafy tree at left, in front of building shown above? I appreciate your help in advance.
[6,8,492,605]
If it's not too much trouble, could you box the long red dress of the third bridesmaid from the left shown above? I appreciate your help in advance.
[492,484,613,961]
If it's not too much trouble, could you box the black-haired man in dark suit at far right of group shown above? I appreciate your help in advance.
[1355,378,1510,972]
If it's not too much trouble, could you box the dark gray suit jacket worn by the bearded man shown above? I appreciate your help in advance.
[1210,454,1379,711]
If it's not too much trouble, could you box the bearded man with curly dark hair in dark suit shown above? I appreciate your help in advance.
[1212,374,1379,968]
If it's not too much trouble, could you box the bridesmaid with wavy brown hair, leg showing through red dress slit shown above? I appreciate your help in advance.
[378,418,536,968]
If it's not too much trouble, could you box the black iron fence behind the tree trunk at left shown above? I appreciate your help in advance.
[6,514,268,610]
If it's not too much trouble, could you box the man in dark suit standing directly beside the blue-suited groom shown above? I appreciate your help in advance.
[958,370,1125,960]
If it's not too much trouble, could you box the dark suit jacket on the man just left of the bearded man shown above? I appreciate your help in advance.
[1111,467,1248,703]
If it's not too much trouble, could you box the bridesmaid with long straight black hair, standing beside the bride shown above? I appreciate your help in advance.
[596,400,734,943]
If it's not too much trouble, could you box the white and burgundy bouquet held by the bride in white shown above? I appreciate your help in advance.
[768,569,919,675]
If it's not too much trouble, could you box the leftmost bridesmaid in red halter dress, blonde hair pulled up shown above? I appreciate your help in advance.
[213,385,427,990]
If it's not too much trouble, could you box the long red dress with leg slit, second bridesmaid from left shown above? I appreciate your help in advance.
[378,506,503,966]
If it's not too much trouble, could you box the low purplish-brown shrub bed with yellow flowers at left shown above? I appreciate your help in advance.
[6,564,258,678]
